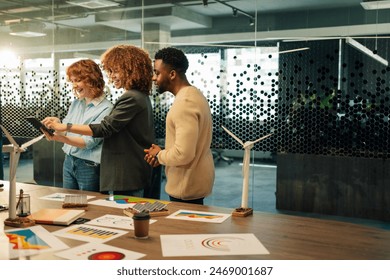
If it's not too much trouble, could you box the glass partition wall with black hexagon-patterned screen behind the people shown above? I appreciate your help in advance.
[0,0,389,209]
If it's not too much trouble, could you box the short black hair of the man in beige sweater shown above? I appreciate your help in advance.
[154,47,188,75]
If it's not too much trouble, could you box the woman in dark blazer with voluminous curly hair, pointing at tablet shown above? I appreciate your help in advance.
[43,45,155,197]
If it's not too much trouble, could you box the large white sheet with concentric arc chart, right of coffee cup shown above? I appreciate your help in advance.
[160,233,269,257]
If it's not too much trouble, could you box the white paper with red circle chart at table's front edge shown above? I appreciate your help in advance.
[55,243,145,261]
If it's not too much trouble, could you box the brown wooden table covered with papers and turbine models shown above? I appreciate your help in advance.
[0,181,390,260]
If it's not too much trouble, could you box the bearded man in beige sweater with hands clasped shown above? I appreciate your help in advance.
[145,47,215,204]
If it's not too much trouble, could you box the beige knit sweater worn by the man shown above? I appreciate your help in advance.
[158,86,215,200]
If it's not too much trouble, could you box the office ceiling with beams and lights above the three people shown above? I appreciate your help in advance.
[0,0,390,56]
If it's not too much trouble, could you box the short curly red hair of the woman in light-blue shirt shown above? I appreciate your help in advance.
[66,59,105,98]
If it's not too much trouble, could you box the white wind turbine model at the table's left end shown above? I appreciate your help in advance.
[0,125,45,227]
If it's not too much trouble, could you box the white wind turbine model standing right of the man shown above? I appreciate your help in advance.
[222,126,272,217]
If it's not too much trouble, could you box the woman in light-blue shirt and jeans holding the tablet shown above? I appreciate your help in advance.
[45,59,112,191]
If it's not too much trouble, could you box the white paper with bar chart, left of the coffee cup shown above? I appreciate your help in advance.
[53,224,127,243]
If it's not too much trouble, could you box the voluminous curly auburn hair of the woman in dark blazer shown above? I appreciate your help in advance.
[101,45,153,95]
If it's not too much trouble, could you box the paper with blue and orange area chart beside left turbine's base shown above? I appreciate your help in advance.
[5,225,69,259]
